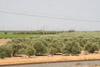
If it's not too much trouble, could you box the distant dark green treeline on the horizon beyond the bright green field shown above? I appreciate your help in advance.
[0,30,75,34]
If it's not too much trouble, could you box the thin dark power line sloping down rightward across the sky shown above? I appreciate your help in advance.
[0,11,100,22]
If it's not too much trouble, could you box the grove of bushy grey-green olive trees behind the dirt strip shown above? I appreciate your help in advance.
[0,31,100,58]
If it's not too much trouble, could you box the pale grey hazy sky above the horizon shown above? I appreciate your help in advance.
[0,0,100,31]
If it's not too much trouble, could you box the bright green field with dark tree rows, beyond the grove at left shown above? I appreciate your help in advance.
[0,31,62,39]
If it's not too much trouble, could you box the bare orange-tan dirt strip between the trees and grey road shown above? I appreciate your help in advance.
[0,54,100,65]
